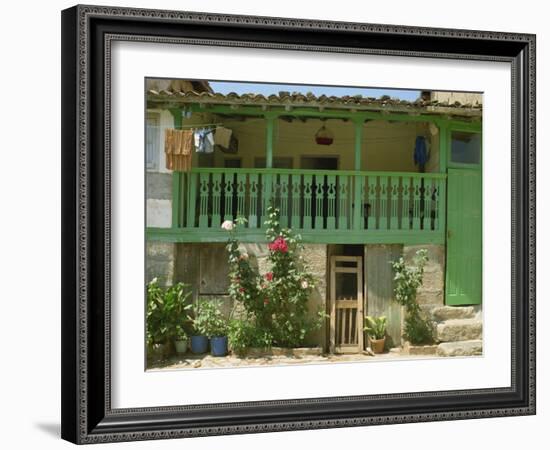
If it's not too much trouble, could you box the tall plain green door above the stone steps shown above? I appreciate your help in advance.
[445,169,482,305]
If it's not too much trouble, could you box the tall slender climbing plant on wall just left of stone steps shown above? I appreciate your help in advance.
[391,249,434,344]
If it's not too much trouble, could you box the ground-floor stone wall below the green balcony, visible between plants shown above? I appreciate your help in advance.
[146,242,445,349]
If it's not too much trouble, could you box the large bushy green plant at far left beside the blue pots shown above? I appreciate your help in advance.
[146,278,192,345]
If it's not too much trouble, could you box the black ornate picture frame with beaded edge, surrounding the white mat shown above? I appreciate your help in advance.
[62,6,535,444]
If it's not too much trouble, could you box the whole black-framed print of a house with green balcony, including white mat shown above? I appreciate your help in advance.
[62,6,535,443]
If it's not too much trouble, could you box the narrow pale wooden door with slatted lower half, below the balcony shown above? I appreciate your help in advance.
[330,256,364,353]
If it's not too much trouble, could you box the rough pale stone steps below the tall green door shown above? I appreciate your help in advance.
[431,306,483,356]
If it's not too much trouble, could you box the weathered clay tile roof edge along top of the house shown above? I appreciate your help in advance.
[147,90,482,117]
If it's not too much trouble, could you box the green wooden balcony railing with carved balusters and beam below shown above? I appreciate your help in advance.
[147,168,446,244]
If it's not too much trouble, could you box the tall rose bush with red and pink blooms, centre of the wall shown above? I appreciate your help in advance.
[222,207,326,351]
